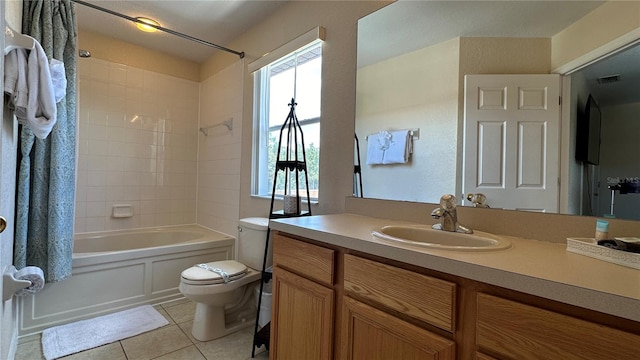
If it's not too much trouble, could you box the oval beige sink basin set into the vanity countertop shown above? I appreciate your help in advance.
[371,225,511,251]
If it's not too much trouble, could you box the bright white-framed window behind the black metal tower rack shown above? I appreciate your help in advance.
[252,40,322,199]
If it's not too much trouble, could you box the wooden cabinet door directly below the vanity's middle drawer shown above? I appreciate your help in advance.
[341,296,455,360]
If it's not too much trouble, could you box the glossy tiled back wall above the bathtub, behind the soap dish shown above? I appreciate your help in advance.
[76,58,200,233]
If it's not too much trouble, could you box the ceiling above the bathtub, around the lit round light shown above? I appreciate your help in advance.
[76,0,287,63]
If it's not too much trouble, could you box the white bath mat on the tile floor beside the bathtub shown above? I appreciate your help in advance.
[42,305,169,360]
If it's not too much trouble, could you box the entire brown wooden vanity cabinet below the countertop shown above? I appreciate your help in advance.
[270,233,640,360]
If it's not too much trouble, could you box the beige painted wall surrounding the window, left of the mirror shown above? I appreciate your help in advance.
[195,1,388,217]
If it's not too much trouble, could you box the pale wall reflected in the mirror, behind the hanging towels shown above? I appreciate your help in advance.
[356,39,460,202]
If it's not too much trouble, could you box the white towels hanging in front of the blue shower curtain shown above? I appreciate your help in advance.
[5,41,57,139]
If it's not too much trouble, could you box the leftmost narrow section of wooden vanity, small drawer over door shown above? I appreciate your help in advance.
[269,234,335,360]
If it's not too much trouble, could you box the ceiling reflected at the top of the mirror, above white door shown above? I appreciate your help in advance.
[358,0,603,66]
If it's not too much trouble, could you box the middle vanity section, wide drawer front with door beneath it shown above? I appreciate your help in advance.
[341,254,456,360]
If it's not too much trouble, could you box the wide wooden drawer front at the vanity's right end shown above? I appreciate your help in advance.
[476,294,640,360]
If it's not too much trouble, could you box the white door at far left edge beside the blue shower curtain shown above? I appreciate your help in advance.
[0,1,22,360]
